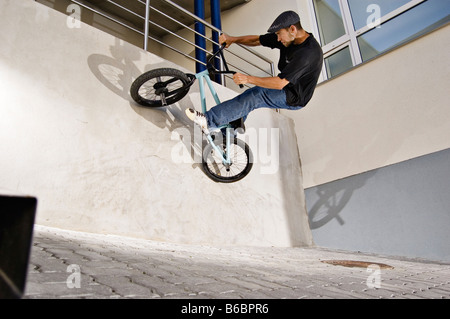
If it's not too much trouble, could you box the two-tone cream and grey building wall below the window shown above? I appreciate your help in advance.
[281,10,450,261]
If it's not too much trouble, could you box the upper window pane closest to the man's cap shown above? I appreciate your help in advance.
[314,0,345,45]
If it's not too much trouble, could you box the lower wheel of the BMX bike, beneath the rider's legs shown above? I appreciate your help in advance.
[203,138,253,183]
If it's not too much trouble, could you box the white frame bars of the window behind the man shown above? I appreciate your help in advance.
[308,0,427,81]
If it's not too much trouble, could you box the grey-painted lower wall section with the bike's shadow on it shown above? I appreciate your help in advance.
[306,149,450,262]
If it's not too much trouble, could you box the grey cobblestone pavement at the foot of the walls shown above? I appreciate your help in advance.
[24,226,450,299]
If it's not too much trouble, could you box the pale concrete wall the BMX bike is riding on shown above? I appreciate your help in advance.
[0,0,312,246]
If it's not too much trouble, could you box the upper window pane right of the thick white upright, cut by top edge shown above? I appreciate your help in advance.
[348,0,411,30]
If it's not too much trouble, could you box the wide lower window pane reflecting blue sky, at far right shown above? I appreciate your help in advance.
[358,0,450,61]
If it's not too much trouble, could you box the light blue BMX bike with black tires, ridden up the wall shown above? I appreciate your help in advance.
[130,44,253,183]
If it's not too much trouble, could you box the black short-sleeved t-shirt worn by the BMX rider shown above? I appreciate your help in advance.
[259,33,323,106]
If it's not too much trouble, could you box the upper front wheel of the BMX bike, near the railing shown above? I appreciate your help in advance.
[130,68,192,107]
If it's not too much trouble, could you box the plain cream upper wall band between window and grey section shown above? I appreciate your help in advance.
[282,26,450,188]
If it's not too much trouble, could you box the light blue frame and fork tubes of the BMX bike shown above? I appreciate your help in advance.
[195,70,231,165]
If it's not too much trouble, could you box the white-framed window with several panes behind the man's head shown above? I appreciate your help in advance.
[310,0,450,79]
